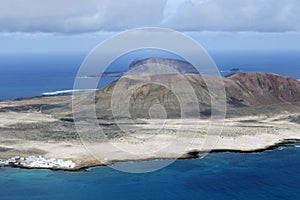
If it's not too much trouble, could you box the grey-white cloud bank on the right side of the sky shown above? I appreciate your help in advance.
[164,0,300,32]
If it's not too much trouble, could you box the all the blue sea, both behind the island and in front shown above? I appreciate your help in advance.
[0,51,300,200]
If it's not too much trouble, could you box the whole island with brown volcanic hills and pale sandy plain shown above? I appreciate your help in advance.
[0,58,300,170]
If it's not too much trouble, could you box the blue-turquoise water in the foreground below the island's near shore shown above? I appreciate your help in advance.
[0,147,300,200]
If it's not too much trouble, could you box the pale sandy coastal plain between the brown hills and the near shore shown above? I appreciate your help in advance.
[0,113,300,171]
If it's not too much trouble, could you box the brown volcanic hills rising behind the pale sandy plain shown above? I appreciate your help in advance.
[96,73,300,118]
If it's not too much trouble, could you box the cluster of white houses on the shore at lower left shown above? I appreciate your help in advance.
[0,156,76,169]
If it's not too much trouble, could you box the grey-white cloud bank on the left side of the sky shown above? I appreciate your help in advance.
[0,0,165,32]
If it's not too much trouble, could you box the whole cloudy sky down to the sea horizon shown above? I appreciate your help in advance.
[0,0,300,52]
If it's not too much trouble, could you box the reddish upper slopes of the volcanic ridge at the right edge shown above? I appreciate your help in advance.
[224,73,300,105]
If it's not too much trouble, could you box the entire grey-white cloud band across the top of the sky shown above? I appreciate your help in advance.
[0,0,300,33]
